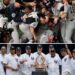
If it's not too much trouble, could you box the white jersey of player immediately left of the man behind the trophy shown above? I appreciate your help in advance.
[19,53,32,75]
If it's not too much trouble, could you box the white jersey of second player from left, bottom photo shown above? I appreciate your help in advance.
[3,53,19,75]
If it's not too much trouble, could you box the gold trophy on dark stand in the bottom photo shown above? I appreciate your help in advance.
[35,55,46,71]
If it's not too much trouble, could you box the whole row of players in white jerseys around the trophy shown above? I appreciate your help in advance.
[0,45,75,75]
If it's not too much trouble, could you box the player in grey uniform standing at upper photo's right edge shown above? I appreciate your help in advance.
[65,0,75,43]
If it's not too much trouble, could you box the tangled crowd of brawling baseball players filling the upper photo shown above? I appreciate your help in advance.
[0,0,75,43]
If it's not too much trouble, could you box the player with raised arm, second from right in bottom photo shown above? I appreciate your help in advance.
[61,45,72,75]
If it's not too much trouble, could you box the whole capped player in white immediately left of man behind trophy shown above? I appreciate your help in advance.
[20,46,32,75]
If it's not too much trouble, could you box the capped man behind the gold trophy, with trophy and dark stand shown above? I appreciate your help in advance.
[32,45,47,75]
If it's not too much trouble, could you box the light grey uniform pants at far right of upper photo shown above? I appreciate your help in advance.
[61,21,75,43]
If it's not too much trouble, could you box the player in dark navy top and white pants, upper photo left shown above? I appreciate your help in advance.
[6,2,20,43]
